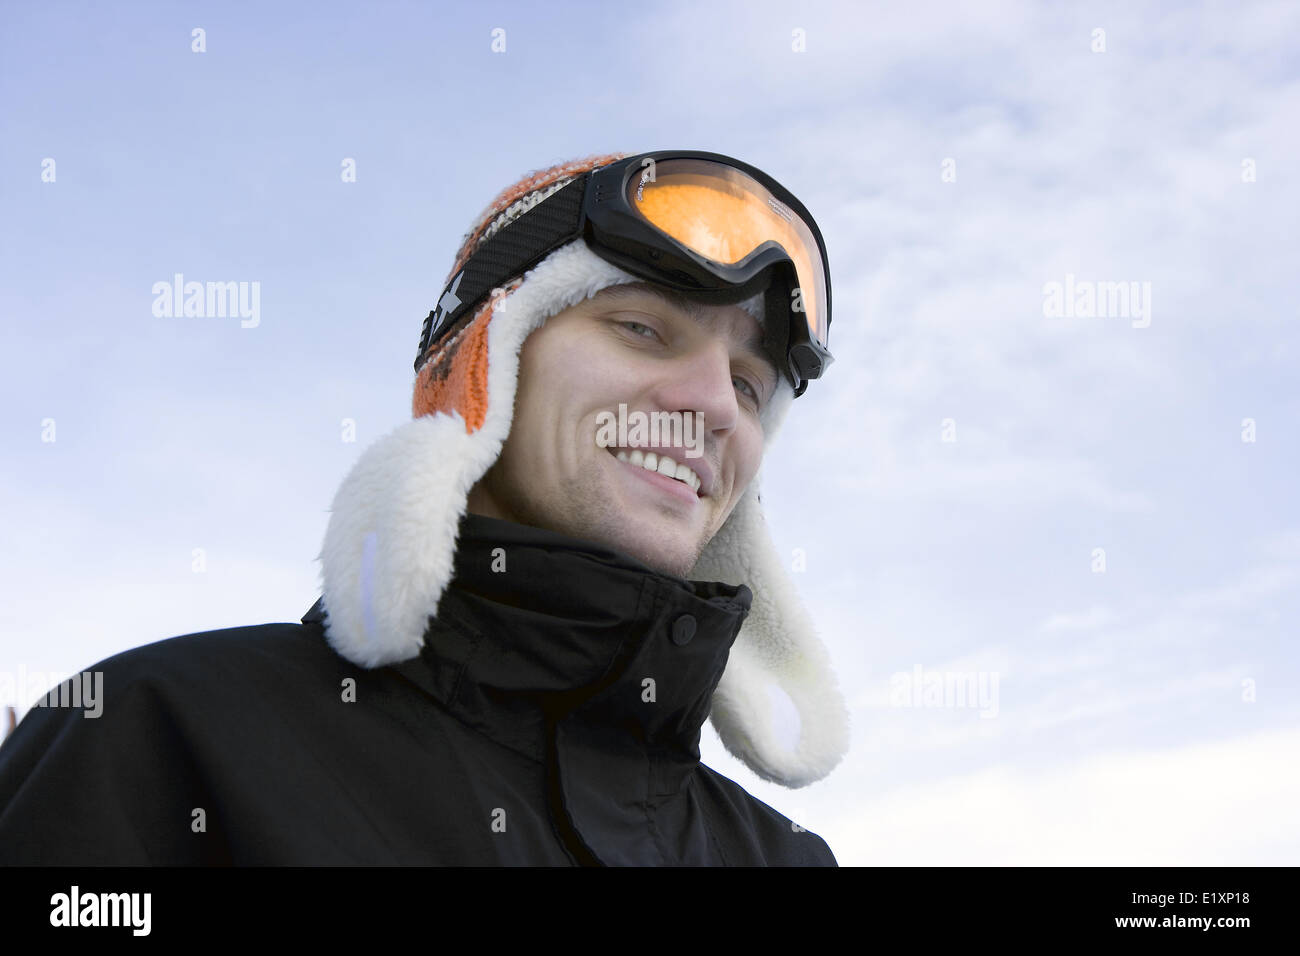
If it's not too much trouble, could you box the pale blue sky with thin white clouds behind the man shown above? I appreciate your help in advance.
[0,1,1300,866]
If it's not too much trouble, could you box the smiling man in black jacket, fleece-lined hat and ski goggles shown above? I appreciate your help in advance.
[0,152,848,866]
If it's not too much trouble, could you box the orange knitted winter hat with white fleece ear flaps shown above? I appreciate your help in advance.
[319,153,849,787]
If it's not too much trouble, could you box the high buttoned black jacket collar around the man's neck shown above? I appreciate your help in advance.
[303,514,753,788]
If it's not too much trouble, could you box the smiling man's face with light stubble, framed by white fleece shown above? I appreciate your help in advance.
[468,282,779,578]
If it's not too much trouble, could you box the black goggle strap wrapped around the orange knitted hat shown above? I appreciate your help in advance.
[415,173,589,368]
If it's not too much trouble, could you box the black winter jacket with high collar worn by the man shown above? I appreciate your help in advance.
[0,515,836,866]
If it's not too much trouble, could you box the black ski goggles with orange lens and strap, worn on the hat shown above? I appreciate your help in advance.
[416,151,833,395]
